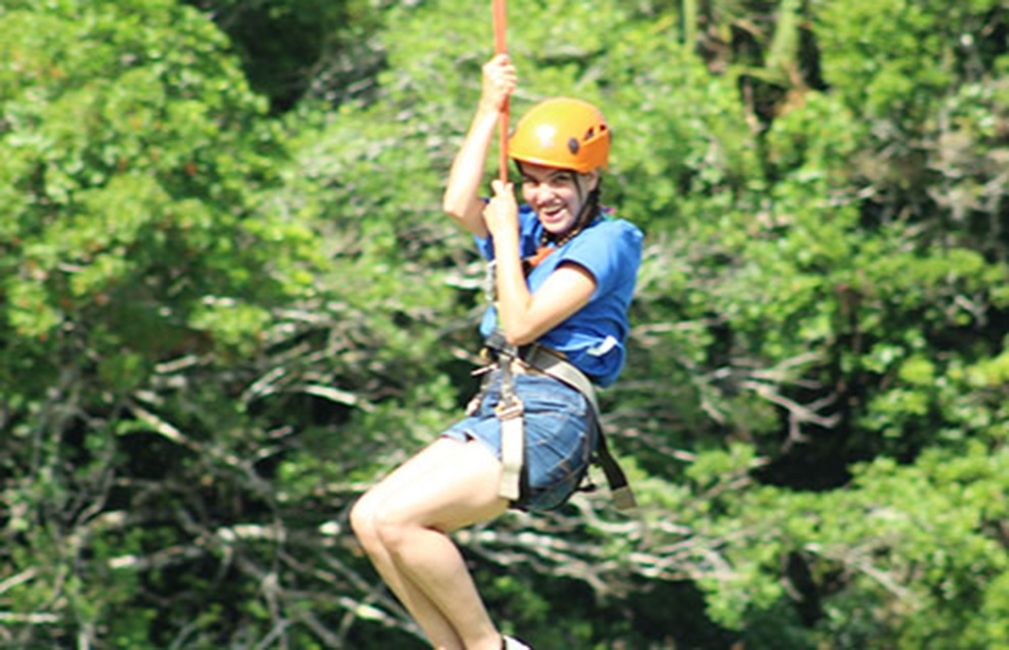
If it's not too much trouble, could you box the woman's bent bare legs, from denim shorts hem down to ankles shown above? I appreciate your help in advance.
[351,439,508,650]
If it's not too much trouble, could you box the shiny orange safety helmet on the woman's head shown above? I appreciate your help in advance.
[509,97,610,174]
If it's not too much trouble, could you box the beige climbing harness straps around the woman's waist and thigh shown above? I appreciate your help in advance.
[478,333,637,510]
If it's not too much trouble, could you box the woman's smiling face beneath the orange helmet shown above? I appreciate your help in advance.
[520,163,598,237]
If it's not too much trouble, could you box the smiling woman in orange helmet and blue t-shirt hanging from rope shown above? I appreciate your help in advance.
[351,55,642,650]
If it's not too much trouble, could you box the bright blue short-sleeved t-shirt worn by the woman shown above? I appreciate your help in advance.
[476,205,644,387]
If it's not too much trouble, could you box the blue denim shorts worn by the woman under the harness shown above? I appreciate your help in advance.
[443,370,598,510]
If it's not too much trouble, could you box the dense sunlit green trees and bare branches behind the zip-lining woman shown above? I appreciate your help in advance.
[0,0,1009,650]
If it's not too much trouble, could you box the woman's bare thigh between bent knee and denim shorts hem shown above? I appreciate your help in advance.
[360,438,508,532]
